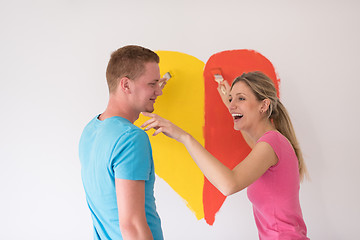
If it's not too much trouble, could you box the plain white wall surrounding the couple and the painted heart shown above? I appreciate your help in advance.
[0,0,360,240]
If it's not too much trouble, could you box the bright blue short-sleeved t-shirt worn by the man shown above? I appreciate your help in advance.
[79,116,163,240]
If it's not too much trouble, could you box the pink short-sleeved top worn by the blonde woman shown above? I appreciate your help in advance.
[247,131,309,240]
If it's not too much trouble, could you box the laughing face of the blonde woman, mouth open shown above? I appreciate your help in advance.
[229,81,262,131]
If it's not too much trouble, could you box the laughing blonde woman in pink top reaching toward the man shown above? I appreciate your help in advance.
[142,72,308,239]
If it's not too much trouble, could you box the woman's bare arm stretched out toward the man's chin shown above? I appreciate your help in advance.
[142,113,278,196]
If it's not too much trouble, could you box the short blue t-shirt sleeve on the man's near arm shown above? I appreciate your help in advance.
[112,129,152,180]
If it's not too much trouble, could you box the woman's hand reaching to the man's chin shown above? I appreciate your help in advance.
[141,112,189,143]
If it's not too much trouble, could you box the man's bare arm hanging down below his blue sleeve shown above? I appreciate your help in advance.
[115,178,153,240]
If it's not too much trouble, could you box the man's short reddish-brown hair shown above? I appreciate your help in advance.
[106,45,160,93]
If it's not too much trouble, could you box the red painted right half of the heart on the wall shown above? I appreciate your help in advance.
[203,49,280,225]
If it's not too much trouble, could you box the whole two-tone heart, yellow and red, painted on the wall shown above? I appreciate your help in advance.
[135,49,280,225]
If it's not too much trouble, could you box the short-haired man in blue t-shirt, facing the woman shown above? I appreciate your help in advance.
[79,46,164,240]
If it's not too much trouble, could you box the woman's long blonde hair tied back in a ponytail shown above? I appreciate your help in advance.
[231,71,308,181]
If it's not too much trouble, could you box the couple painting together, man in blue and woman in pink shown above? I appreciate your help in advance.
[79,46,308,240]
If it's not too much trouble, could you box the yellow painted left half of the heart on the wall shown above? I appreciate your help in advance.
[135,51,205,219]
